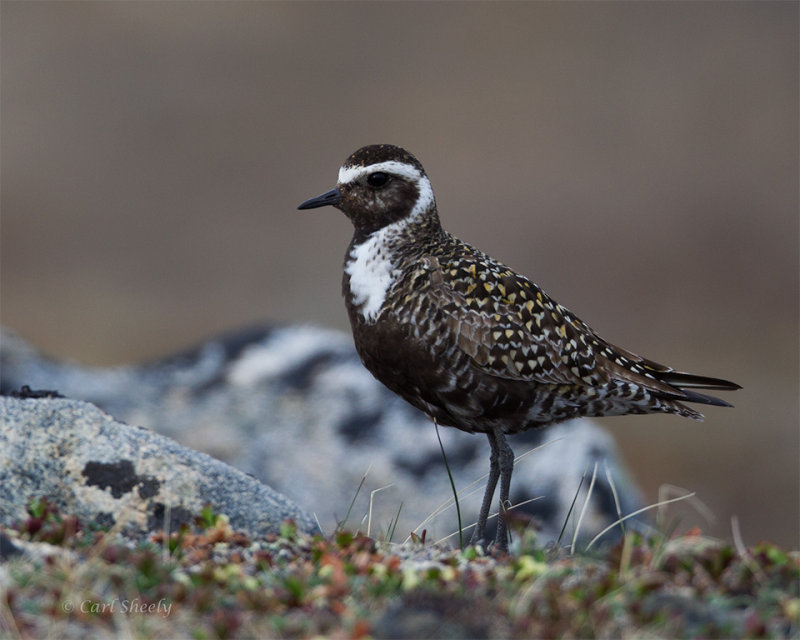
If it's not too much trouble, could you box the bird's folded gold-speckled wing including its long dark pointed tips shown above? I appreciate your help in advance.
[406,250,740,405]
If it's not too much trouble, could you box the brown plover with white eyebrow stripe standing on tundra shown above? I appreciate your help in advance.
[298,144,741,552]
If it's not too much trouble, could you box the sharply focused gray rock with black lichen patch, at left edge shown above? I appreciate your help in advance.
[0,397,317,539]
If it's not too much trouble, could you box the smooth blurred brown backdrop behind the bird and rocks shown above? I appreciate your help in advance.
[0,2,800,547]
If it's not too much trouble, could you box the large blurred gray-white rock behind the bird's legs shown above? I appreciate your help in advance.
[0,326,641,542]
